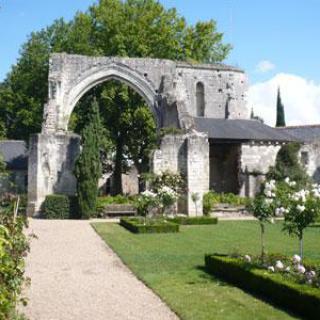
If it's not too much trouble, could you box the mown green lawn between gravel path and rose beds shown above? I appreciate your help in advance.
[93,221,320,320]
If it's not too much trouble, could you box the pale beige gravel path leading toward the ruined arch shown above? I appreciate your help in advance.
[21,219,178,320]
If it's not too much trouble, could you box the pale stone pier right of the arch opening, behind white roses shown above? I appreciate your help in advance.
[152,132,209,216]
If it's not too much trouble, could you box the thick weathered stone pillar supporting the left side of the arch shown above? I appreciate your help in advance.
[28,133,80,216]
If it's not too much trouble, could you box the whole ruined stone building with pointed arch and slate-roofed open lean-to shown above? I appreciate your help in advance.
[28,53,294,215]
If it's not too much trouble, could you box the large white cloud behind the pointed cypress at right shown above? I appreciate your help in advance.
[248,73,320,126]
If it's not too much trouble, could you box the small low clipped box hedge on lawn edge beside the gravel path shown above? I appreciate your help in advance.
[120,217,179,233]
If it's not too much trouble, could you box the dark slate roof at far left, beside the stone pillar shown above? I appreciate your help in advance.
[0,140,28,170]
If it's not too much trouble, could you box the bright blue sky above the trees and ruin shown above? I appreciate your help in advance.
[0,0,320,122]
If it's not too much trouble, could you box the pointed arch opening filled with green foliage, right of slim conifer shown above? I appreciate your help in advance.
[68,76,157,195]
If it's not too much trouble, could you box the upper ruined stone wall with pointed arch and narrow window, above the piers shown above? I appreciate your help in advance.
[43,54,249,133]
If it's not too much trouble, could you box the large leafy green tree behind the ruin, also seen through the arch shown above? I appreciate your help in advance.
[0,0,231,193]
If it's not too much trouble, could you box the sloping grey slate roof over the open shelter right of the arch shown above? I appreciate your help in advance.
[194,118,296,142]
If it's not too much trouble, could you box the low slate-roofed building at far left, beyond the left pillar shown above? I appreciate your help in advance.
[0,140,28,194]
